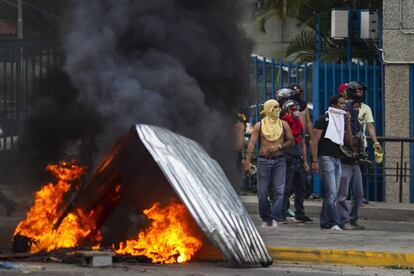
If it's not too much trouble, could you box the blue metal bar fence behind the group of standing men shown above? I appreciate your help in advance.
[252,56,385,201]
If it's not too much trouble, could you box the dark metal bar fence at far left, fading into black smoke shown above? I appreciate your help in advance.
[0,40,62,152]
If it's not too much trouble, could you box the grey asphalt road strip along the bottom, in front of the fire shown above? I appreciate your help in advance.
[0,263,414,276]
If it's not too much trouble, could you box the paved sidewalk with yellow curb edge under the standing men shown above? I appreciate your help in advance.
[241,196,414,267]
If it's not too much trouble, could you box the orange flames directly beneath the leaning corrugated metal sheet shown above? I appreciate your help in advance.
[115,200,202,264]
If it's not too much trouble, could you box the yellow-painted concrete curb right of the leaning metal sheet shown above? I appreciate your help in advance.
[268,247,414,268]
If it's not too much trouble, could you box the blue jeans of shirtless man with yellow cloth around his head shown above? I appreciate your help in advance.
[257,157,286,221]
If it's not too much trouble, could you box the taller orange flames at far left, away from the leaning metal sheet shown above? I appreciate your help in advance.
[14,161,102,253]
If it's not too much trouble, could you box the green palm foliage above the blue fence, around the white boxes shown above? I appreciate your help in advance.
[257,0,382,62]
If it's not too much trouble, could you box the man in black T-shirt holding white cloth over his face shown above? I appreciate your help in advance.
[311,95,352,230]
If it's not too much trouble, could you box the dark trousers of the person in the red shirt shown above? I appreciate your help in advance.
[283,157,305,217]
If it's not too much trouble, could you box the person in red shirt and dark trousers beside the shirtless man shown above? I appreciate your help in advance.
[282,100,313,222]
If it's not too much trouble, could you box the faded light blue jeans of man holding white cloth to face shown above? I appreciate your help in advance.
[319,156,342,229]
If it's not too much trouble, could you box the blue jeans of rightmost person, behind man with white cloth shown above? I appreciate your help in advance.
[337,164,364,225]
